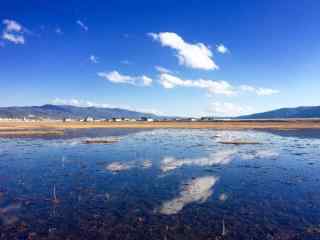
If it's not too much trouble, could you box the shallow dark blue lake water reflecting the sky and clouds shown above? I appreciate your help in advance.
[0,129,320,240]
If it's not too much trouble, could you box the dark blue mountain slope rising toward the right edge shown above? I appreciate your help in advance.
[237,106,320,119]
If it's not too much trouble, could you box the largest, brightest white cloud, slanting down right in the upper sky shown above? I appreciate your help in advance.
[148,32,219,70]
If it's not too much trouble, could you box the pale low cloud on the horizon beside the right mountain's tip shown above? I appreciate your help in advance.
[208,102,253,117]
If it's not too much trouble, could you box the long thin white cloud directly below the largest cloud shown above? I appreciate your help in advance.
[160,73,235,96]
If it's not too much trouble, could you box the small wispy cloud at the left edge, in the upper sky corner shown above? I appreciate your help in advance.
[2,19,25,44]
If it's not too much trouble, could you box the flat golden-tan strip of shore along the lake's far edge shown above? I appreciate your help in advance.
[0,120,320,136]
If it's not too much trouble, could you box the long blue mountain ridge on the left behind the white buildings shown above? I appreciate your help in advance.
[0,104,159,119]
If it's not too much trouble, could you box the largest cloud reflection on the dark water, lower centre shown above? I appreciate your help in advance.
[159,176,219,215]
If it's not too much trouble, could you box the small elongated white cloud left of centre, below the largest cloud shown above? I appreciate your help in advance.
[98,71,152,86]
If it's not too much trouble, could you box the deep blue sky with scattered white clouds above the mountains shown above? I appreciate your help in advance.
[0,0,320,116]
